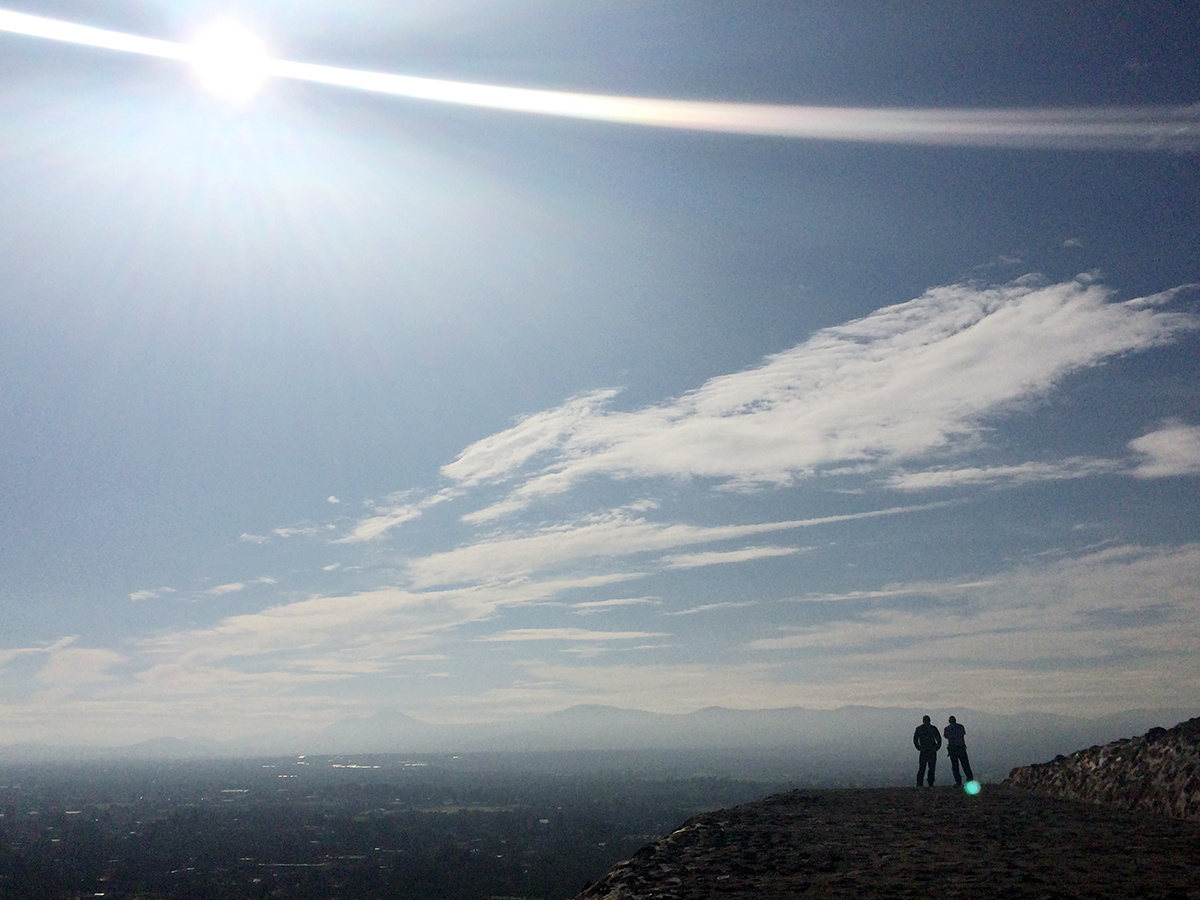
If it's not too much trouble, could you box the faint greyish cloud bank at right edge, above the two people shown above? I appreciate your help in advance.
[749,545,1200,666]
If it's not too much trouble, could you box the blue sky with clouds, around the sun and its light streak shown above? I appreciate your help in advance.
[0,0,1200,743]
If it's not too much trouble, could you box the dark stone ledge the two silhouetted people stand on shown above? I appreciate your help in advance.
[580,786,1200,900]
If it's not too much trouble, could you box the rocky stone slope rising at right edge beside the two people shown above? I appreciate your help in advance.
[1004,719,1200,822]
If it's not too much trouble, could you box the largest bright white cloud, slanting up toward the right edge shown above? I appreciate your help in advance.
[443,280,1200,521]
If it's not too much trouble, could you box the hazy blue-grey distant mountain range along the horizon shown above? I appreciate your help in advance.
[0,706,1200,785]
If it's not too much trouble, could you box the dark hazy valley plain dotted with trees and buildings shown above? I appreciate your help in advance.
[0,756,788,900]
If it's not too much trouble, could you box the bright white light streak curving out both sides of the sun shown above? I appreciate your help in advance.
[0,10,1200,151]
